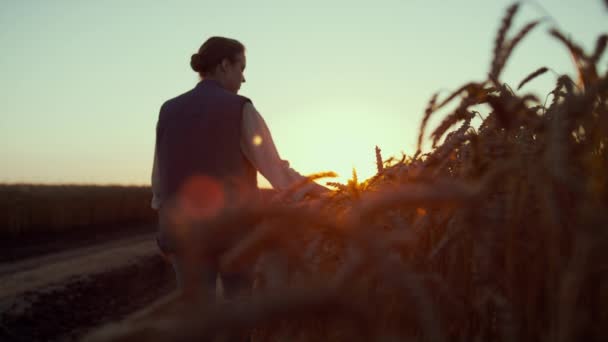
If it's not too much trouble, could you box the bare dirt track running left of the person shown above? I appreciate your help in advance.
[0,233,174,341]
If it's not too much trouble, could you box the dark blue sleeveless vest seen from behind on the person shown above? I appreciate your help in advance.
[156,80,258,210]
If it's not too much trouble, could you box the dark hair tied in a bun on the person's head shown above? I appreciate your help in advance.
[190,36,245,77]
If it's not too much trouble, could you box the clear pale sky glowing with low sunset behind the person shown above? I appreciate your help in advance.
[0,0,608,186]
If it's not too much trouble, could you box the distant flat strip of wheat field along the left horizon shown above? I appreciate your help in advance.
[0,184,157,239]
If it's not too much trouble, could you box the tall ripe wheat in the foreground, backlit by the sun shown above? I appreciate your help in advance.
[88,5,608,341]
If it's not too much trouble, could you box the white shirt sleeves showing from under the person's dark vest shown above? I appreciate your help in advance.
[151,102,315,210]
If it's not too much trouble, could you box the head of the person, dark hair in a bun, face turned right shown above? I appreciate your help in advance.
[190,37,247,94]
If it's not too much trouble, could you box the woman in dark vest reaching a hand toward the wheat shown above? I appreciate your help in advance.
[151,37,328,298]
